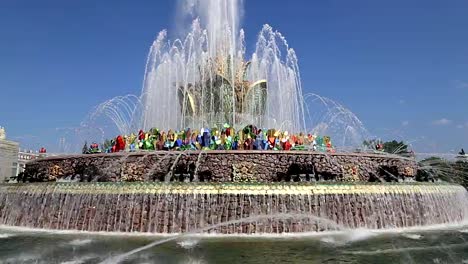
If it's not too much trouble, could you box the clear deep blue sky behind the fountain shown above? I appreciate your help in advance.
[0,0,468,152]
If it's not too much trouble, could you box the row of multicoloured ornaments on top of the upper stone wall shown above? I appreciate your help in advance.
[88,124,334,153]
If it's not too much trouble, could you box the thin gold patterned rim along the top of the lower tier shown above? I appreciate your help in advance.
[0,183,464,195]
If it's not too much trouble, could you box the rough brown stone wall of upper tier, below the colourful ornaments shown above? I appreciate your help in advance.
[19,151,417,182]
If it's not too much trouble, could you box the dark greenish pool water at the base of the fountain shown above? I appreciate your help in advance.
[0,226,468,264]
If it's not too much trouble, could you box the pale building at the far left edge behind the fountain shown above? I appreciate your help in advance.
[0,127,19,182]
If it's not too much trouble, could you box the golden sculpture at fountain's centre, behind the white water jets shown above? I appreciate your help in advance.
[177,56,267,122]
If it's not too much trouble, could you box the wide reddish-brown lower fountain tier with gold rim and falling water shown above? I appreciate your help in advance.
[0,183,467,234]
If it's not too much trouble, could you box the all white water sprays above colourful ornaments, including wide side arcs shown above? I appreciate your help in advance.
[77,0,369,149]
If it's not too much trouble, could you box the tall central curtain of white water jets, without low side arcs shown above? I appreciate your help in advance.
[141,0,305,131]
